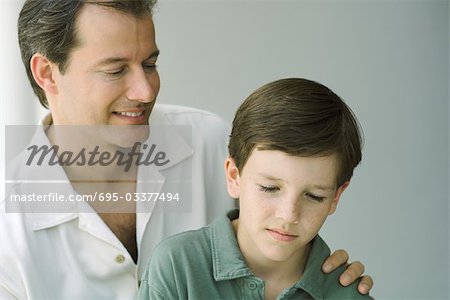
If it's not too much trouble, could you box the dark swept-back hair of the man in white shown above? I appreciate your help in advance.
[18,0,156,108]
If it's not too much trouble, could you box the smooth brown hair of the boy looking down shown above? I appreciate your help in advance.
[228,78,362,187]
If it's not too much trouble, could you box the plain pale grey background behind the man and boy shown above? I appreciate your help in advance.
[0,0,450,299]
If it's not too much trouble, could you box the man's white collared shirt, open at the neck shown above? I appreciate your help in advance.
[0,105,233,299]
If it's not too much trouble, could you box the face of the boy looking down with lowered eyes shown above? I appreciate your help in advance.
[225,148,348,262]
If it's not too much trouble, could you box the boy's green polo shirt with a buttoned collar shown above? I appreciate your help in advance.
[139,210,371,300]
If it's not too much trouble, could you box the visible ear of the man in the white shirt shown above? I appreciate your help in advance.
[30,53,59,95]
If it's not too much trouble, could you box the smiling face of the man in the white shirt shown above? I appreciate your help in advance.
[48,4,160,125]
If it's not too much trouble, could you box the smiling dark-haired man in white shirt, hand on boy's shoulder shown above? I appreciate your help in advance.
[0,0,372,299]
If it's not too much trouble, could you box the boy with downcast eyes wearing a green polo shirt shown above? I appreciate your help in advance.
[140,78,370,299]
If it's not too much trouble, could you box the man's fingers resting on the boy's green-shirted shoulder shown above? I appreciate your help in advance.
[322,249,373,294]
